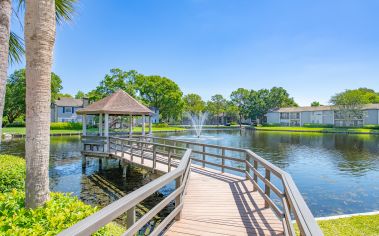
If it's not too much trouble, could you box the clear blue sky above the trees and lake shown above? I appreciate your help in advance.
[9,0,379,105]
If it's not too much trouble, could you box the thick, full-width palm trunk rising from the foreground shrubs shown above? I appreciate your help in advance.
[25,0,55,208]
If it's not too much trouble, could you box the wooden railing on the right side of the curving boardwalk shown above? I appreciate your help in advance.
[130,135,322,235]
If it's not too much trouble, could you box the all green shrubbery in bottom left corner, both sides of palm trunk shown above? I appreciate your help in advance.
[0,155,125,235]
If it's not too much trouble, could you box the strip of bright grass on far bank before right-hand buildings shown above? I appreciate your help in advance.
[254,126,379,134]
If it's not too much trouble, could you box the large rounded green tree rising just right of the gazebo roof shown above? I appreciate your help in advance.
[135,75,183,121]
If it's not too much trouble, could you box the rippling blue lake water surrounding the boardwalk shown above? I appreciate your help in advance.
[1,130,379,216]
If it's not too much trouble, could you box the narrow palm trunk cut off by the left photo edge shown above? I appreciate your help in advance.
[0,0,12,143]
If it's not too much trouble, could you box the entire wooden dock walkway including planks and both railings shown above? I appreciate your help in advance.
[59,136,323,236]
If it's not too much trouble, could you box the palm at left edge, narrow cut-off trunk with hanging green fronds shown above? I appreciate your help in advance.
[0,0,77,142]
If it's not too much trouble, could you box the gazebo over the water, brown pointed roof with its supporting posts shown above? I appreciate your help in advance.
[76,89,153,137]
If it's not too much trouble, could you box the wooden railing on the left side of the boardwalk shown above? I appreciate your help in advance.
[59,138,191,236]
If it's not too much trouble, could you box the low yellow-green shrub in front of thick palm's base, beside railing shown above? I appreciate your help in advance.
[0,190,123,235]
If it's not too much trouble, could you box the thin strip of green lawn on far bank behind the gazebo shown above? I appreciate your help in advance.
[3,127,186,134]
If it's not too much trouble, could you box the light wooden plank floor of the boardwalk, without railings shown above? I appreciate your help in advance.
[96,150,283,235]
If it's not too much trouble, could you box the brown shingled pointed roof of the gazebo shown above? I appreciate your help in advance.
[76,89,153,115]
